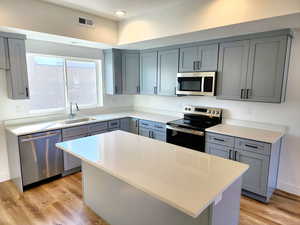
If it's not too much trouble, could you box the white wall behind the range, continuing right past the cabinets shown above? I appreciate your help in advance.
[134,31,300,195]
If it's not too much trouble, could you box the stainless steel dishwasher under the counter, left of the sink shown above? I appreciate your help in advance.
[19,130,63,186]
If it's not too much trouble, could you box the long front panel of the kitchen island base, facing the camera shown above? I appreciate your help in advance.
[82,162,212,225]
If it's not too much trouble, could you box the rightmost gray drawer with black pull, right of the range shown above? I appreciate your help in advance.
[235,138,271,155]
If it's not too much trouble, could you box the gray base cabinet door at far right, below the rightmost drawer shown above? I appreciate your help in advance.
[236,151,269,196]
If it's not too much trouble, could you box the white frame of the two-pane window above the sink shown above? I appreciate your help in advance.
[26,52,103,115]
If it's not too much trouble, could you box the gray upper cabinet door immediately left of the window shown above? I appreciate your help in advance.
[7,39,29,99]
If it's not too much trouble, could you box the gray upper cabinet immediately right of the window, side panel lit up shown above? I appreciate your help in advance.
[104,49,122,95]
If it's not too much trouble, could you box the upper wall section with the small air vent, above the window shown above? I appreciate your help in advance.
[0,0,118,44]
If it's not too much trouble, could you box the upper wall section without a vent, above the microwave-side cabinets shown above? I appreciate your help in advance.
[119,0,300,44]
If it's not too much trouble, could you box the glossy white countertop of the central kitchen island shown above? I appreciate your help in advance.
[57,131,248,217]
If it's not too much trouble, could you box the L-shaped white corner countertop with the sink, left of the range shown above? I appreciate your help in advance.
[6,111,181,136]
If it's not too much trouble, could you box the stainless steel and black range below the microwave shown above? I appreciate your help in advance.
[167,106,222,152]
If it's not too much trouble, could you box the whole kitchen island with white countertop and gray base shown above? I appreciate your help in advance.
[56,131,248,225]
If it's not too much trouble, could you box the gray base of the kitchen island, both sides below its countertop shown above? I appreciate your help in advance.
[82,162,241,225]
